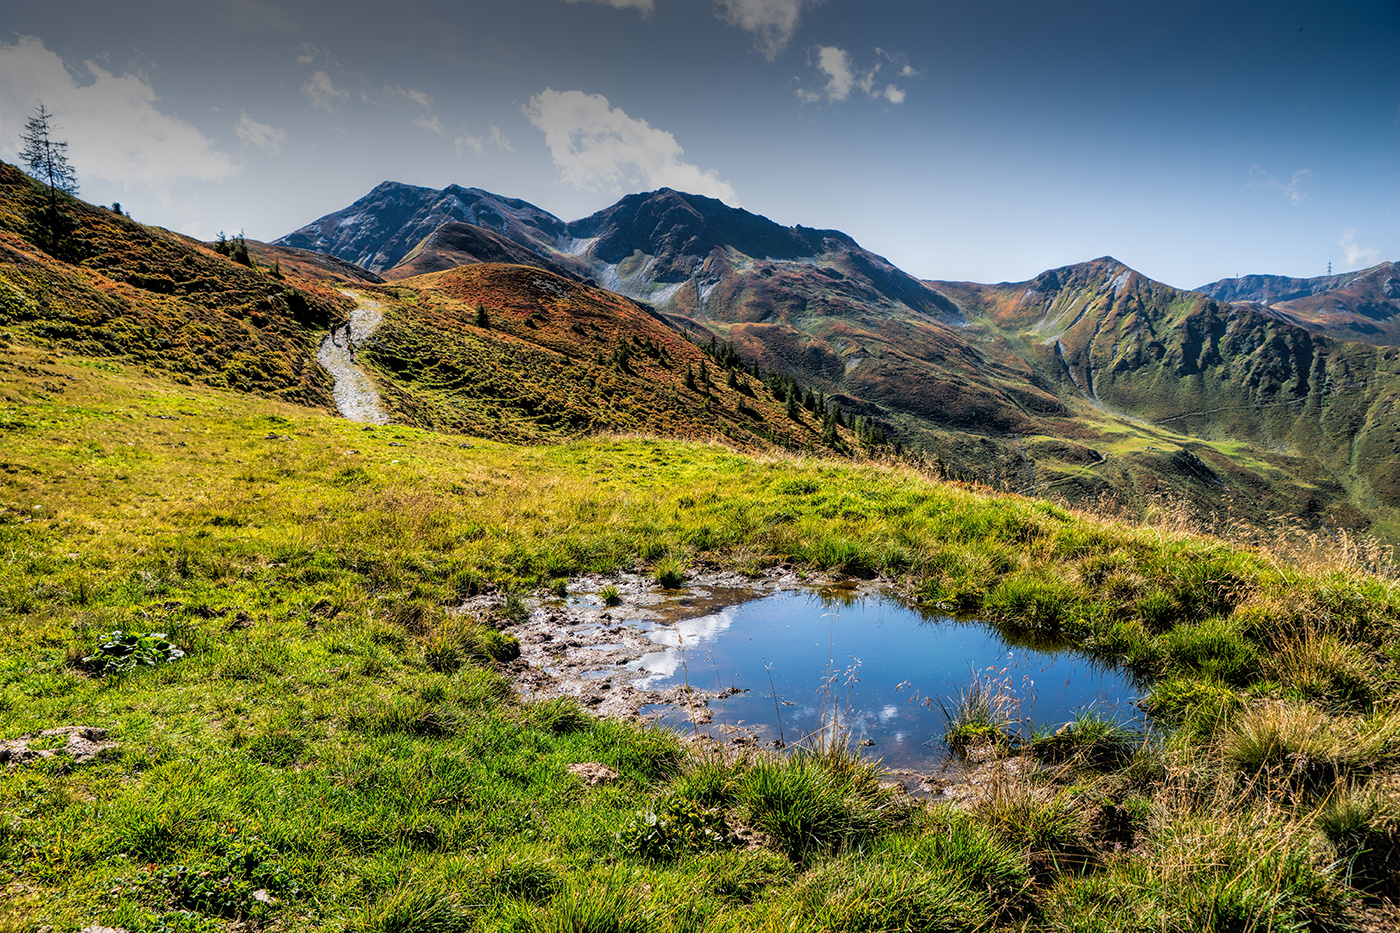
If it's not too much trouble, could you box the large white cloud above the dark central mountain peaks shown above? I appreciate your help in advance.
[525,88,738,205]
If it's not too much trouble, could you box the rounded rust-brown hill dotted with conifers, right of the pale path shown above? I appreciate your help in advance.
[347,265,850,450]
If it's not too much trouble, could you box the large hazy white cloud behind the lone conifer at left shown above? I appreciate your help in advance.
[0,36,239,191]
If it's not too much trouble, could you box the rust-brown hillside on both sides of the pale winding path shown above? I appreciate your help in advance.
[0,164,860,450]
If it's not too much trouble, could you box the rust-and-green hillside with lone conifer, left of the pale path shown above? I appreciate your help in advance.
[0,163,349,405]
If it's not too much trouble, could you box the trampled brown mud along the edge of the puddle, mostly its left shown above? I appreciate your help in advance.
[462,566,991,797]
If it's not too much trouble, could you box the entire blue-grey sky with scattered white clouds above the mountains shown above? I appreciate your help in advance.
[0,0,1400,287]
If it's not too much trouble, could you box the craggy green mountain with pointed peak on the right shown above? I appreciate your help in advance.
[935,258,1400,524]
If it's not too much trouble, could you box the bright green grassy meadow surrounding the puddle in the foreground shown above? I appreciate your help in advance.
[0,342,1400,933]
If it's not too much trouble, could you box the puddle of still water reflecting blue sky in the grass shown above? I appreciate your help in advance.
[626,591,1138,769]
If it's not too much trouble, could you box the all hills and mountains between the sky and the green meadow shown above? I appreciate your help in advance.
[0,164,1400,539]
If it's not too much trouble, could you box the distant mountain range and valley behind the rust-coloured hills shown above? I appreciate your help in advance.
[277,182,1400,531]
